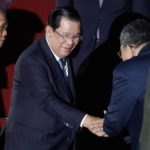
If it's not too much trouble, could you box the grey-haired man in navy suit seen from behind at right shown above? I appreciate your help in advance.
[99,19,150,150]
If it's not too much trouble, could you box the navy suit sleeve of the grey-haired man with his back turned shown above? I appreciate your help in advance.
[103,69,137,137]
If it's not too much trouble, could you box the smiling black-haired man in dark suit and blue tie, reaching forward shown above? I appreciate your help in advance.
[5,8,103,150]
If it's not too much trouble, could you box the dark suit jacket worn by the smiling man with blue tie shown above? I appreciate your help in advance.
[5,36,85,150]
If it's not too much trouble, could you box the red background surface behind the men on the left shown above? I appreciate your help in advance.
[0,0,55,130]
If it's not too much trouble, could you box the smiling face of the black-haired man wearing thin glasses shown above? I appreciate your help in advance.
[46,18,80,58]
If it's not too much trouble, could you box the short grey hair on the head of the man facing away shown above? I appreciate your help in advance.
[120,19,150,48]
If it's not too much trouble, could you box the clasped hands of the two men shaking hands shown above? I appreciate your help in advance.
[82,115,108,137]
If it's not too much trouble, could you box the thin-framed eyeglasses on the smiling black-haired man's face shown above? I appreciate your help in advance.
[55,30,82,41]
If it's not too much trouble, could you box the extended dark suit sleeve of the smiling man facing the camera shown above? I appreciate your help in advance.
[20,59,85,130]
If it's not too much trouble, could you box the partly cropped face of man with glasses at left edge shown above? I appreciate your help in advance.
[0,12,7,47]
